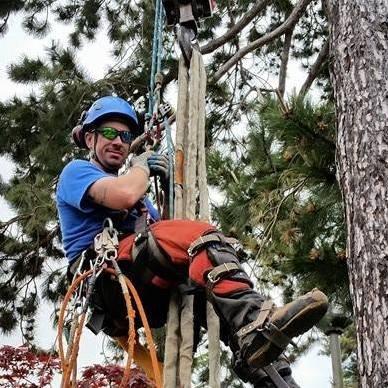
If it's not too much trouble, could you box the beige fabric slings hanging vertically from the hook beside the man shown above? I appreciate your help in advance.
[164,50,220,388]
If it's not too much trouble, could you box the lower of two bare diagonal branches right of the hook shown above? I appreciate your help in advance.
[213,0,312,82]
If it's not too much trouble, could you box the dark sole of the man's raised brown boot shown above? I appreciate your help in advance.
[247,291,328,368]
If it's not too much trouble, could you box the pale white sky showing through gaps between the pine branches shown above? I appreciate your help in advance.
[0,10,331,388]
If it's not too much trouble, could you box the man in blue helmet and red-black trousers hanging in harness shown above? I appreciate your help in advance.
[57,96,328,387]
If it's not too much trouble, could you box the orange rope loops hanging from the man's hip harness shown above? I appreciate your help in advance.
[58,267,162,388]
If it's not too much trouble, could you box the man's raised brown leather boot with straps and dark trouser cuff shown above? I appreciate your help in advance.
[209,289,328,368]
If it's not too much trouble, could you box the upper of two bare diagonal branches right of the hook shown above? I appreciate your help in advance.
[200,0,271,54]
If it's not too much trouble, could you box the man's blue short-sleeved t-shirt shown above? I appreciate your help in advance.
[56,160,159,262]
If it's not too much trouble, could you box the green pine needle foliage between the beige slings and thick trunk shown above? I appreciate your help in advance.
[208,97,350,306]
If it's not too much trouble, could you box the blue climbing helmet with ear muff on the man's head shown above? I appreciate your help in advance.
[72,96,140,148]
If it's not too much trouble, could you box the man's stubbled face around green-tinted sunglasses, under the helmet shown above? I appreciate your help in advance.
[85,120,130,170]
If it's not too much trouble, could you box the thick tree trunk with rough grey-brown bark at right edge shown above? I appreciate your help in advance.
[329,0,388,388]
